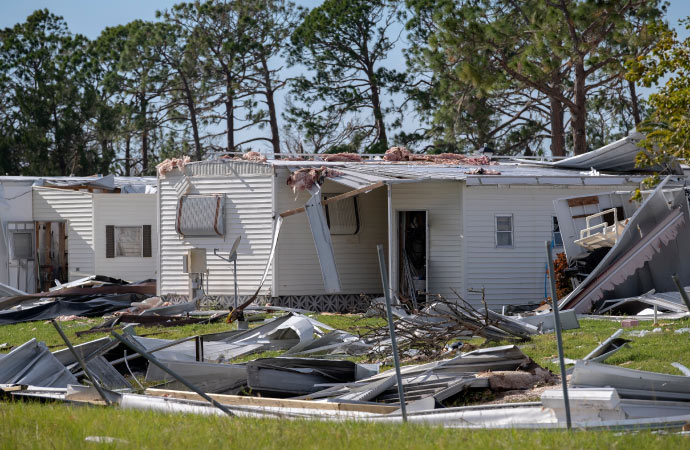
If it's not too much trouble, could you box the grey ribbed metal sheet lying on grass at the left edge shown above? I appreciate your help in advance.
[0,339,77,388]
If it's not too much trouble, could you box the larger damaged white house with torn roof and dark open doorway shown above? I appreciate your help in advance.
[158,132,672,311]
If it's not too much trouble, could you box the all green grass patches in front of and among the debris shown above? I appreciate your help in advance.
[0,315,690,449]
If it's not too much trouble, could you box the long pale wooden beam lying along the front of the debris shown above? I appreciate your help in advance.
[144,388,400,414]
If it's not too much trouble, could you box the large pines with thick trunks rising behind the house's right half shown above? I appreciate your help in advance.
[407,0,665,155]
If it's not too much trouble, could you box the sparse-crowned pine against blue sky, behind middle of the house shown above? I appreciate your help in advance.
[287,0,404,152]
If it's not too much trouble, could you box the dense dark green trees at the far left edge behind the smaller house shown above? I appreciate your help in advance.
[0,10,112,175]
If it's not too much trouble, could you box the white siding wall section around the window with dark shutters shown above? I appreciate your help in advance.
[93,194,158,281]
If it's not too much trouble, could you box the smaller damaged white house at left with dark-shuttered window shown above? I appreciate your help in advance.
[0,175,158,293]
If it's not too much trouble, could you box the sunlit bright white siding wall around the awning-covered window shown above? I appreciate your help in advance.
[159,168,273,295]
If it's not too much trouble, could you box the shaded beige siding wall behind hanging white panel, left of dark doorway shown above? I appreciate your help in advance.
[275,169,388,295]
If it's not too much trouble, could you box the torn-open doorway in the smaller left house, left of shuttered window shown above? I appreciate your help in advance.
[35,222,69,292]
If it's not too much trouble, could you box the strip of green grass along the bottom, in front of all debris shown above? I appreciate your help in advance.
[0,403,690,450]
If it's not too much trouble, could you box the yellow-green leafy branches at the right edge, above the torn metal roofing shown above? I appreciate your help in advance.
[628,17,690,186]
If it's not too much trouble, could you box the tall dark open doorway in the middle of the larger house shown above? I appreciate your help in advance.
[398,211,429,309]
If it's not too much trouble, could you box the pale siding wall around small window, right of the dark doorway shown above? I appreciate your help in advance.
[463,186,628,309]
